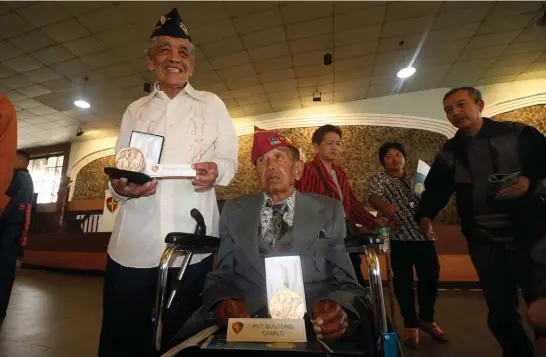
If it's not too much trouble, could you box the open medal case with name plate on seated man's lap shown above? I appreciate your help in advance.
[227,255,307,343]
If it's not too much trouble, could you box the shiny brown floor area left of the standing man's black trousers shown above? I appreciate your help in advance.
[0,269,102,357]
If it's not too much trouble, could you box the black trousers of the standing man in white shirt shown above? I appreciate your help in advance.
[99,255,213,357]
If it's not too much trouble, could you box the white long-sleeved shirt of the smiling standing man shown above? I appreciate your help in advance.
[108,83,239,268]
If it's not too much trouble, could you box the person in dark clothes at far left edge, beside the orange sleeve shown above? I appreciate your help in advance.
[0,151,34,318]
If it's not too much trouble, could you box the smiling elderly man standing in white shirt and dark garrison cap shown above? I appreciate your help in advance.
[99,9,238,357]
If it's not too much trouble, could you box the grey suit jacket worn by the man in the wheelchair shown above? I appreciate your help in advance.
[203,192,365,316]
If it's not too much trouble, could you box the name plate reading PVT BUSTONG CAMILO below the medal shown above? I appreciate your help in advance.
[226,318,307,342]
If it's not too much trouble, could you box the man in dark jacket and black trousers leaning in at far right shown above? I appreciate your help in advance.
[417,87,546,357]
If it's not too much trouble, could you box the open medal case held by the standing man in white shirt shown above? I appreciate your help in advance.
[104,131,196,185]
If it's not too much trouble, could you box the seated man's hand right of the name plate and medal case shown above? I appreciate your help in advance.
[313,300,349,340]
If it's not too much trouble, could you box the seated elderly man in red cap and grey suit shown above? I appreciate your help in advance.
[178,128,369,340]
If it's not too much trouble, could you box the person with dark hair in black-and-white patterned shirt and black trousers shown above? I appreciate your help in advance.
[369,142,447,348]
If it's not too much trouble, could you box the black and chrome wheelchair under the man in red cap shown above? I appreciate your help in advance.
[152,210,403,357]
